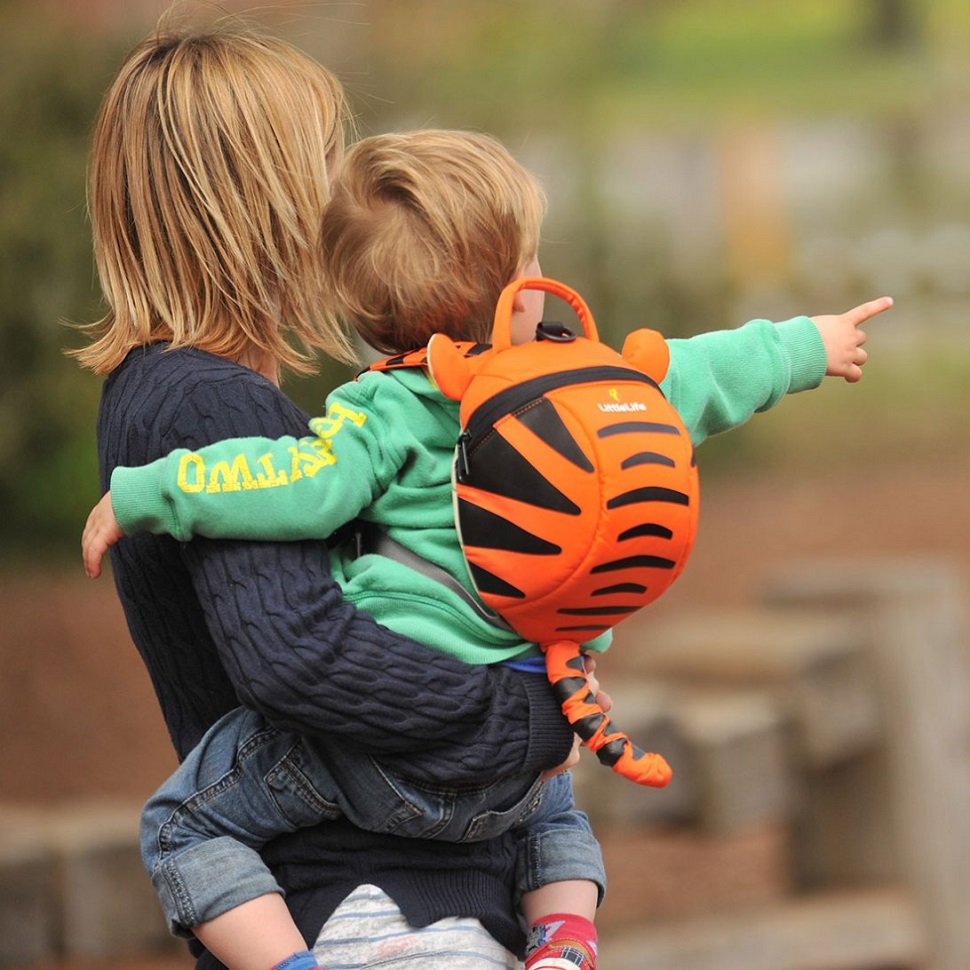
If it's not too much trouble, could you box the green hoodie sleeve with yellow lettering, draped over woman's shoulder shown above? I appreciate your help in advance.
[111,382,402,541]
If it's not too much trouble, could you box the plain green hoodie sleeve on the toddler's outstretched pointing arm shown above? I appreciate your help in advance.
[660,317,826,445]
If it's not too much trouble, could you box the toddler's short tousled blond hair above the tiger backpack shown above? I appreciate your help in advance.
[321,130,545,354]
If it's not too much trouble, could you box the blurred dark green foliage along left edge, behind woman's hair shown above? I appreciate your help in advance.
[0,8,117,555]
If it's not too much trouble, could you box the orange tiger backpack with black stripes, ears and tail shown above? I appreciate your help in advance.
[374,277,699,787]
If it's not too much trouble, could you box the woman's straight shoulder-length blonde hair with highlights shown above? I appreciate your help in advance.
[75,21,353,374]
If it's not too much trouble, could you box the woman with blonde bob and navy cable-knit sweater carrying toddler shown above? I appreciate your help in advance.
[77,17,588,970]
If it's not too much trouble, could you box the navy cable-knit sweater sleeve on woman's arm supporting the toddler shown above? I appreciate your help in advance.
[163,366,572,782]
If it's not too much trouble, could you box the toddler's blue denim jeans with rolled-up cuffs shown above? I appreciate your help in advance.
[141,708,606,936]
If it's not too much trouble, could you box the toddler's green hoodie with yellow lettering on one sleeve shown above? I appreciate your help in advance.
[111,317,825,663]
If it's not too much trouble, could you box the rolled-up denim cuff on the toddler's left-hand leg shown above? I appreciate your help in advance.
[152,838,283,937]
